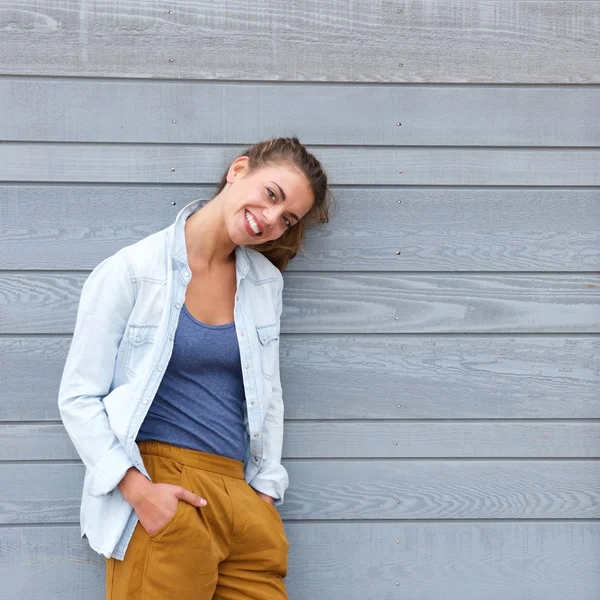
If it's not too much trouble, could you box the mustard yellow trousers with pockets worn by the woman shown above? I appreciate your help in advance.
[106,441,289,600]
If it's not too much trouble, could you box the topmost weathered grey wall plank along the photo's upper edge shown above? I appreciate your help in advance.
[0,0,600,83]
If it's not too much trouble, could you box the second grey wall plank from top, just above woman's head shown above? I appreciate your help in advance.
[0,78,600,147]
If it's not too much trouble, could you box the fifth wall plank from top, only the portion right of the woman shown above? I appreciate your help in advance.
[282,273,600,333]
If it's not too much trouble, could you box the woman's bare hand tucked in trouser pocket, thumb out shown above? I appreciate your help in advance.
[119,467,207,535]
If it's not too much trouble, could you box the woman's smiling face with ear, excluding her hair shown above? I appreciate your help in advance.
[224,156,314,246]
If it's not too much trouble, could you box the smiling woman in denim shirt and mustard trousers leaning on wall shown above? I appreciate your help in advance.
[58,138,330,600]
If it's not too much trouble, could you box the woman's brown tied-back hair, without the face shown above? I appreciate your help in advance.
[213,137,332,271]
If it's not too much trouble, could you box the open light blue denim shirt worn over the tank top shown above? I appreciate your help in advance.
[58,200,288,560]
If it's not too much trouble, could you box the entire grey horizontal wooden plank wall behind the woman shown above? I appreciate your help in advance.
[0,0,600,600]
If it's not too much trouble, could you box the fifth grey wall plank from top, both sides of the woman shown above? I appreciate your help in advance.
[0,272,600,334]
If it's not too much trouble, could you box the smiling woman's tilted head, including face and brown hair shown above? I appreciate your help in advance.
[215,137,331,270]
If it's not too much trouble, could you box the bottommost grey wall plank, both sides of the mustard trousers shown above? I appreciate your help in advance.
[0,521,600,600]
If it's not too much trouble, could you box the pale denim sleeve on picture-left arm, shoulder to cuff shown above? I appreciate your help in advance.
[58,253,135,496]
